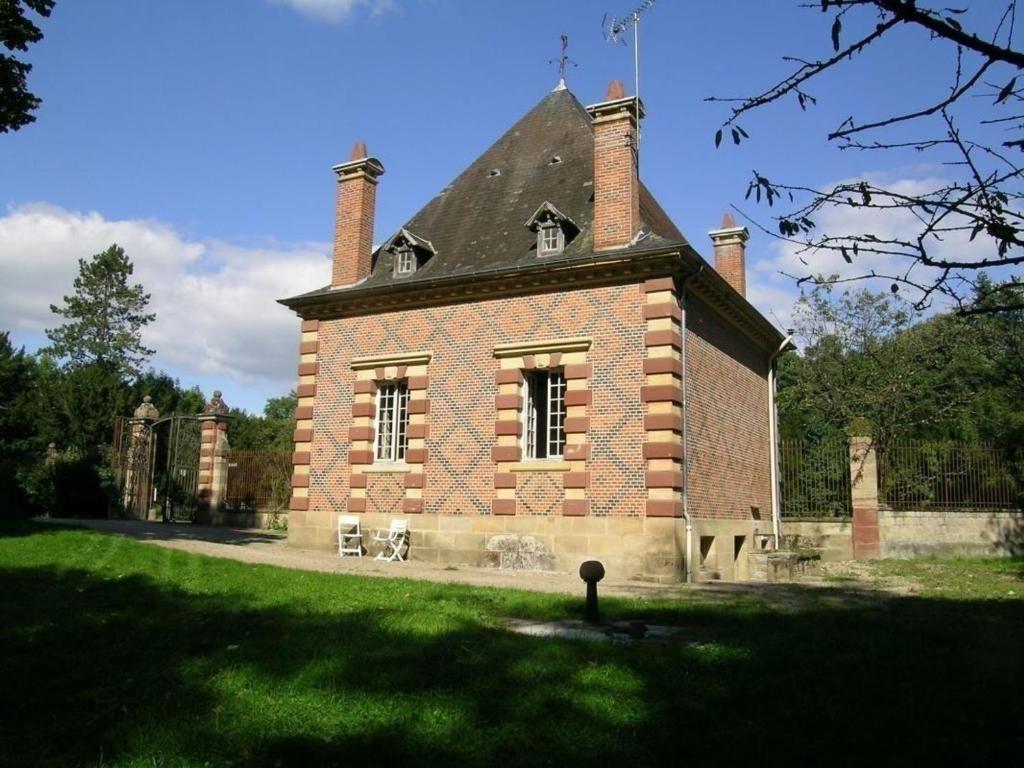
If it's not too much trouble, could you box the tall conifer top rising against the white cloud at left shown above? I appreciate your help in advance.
[46,244,156,376]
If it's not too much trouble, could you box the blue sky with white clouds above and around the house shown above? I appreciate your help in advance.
[0,0,1007,411]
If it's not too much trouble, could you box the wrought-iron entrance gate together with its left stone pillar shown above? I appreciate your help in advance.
[114,414,202,522]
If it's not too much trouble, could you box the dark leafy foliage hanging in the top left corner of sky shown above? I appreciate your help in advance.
[0,0,54,133]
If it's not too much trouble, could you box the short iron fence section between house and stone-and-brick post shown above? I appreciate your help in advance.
[779,440,852,517]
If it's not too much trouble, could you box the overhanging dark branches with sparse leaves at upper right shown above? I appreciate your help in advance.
[709,0,1024,313]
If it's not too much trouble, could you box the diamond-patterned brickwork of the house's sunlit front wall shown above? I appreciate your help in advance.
[299,284,646,515]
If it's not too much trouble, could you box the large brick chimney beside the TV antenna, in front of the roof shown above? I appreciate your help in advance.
[587,80,644,251]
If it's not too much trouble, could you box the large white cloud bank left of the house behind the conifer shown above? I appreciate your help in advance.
[0,203,331,403]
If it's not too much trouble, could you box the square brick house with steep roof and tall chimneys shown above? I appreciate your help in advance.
[282,82,782,580]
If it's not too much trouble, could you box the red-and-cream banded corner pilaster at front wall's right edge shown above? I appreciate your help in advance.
[640,278,685,517]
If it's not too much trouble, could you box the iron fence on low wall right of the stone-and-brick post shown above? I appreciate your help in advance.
[879,441,1024,511]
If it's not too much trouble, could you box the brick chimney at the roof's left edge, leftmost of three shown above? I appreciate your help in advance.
[331,141,384,286]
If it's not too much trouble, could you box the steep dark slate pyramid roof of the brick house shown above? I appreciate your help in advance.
[285,84,686,303]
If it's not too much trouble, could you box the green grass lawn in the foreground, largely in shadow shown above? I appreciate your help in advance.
[0,524,1024,768]
